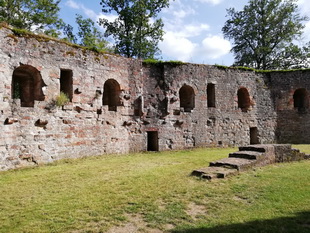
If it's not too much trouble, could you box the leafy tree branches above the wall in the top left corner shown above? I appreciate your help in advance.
[0,0,63,35]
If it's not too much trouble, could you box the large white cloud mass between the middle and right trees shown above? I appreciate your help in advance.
[159,0,231,62]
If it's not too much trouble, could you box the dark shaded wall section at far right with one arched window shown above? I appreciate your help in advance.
[270,70,310,144]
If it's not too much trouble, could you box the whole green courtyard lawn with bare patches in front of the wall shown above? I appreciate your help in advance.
[0,145,310,233]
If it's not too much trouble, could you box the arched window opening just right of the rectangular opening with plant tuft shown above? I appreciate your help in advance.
[102,79,121,111]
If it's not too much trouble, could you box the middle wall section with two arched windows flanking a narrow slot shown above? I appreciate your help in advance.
[140,64,276,150]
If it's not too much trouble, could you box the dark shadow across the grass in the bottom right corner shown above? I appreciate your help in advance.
[171,211,310,233]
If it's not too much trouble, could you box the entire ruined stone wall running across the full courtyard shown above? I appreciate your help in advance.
[0,28,310,170]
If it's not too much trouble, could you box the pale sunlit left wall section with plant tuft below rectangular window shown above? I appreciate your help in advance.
[0,29,141,170]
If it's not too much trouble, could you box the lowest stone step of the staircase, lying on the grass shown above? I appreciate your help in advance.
[191,167,238,180]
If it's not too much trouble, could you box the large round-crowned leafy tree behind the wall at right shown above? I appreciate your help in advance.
[222,0,308,69]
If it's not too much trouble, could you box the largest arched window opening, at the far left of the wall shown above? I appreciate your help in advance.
[12,65,45,107]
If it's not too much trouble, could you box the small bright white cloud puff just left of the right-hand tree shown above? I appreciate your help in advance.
[201,36,231,59]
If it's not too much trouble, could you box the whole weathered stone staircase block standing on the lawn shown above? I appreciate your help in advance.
[191,144,309,180]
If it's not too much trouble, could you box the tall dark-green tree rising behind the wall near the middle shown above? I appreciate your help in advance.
[99,0,169,59]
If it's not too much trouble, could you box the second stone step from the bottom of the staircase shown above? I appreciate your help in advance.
[210,158,257,171]
